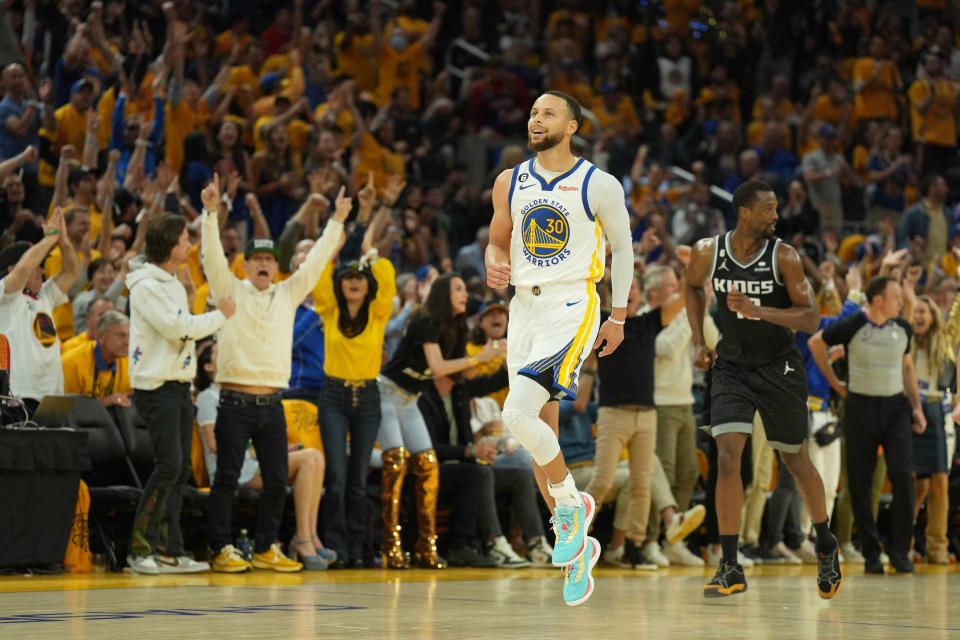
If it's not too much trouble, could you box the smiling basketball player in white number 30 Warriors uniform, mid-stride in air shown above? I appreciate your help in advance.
[485,91,633,605]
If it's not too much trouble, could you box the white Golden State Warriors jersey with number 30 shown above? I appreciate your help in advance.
[508,158,604,286]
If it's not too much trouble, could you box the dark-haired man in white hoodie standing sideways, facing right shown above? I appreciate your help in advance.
[127,214,234,574]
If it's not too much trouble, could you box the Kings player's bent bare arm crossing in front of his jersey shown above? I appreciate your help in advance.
[744,244,820,333]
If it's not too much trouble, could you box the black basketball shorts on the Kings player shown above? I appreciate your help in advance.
[710,349,809,453]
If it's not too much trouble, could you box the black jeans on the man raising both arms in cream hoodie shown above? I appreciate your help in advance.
[207,389,288,553]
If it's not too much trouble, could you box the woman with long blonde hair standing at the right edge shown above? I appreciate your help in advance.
[911,296,957,564]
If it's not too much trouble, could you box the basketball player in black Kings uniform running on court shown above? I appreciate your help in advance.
[686,180,843,598]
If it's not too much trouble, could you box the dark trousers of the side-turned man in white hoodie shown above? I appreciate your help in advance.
[130,382,193,557]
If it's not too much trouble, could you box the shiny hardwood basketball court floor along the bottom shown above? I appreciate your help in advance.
[0,565,960,640]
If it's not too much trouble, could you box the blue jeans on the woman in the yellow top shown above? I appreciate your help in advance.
[319,378,380,560]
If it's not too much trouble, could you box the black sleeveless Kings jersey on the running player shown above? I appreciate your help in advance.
[710,232,796,367]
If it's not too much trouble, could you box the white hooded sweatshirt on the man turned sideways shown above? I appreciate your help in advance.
[127,256,227,391]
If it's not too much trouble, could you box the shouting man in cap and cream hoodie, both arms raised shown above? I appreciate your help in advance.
[200,174,352,573]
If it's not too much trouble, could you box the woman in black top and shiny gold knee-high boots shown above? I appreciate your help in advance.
[377,274,506,569]
